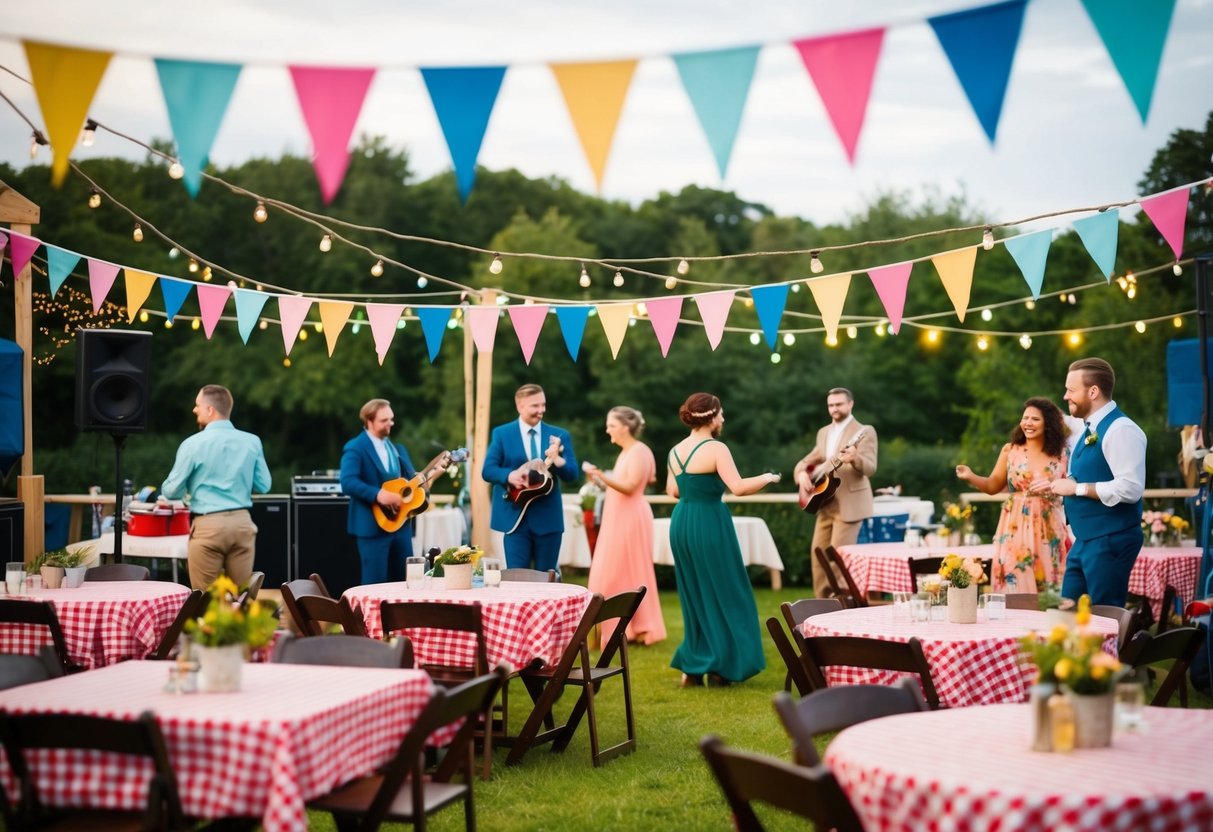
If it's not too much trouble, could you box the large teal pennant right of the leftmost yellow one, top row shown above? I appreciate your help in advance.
[155,58,240,196]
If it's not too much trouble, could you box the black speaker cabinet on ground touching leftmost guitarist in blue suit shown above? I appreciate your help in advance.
[292,496,363,595]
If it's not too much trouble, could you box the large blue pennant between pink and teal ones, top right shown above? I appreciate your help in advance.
[927,0,1027,144]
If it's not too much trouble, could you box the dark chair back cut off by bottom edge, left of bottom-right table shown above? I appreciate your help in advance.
[699,736,864,832]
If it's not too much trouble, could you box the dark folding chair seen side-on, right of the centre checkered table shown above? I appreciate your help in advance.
[506,586,645,767]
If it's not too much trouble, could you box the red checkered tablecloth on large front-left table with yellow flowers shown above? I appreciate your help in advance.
[0,661,433,832]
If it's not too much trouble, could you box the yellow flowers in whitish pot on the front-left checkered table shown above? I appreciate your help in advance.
[186,575,278,693]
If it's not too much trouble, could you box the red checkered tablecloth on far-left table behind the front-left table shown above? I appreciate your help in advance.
[0,581,189,668]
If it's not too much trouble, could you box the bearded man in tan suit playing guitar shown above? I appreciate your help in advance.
[795,387,877,598]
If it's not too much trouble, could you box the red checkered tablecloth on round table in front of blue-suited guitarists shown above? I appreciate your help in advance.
[343,581,591,668]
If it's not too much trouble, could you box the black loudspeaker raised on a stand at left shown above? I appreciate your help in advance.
[75,329,152,434]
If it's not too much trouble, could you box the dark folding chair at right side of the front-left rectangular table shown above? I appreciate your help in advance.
[308,665,508,832]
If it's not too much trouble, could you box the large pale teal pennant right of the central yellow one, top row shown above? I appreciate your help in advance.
[673,46,759,179]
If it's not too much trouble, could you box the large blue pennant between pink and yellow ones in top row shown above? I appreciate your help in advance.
[421,67,506,201]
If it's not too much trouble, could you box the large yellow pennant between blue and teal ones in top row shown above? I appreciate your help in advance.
[551,61,637,190]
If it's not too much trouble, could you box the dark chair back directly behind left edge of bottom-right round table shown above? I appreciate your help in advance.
[774,679,929,767]
